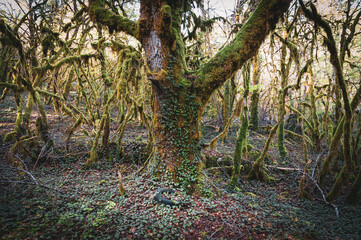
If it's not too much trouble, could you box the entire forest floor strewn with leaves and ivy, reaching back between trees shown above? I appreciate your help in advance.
[0,96,361,239]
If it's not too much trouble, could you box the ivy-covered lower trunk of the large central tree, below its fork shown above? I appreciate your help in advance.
[149,86,204,190]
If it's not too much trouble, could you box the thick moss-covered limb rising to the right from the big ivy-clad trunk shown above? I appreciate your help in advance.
[195,0,291,101]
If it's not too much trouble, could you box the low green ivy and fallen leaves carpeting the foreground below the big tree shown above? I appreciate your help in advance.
[0,158,361,239]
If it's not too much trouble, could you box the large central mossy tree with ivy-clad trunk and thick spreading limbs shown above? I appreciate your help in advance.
[89,0,291,191]
